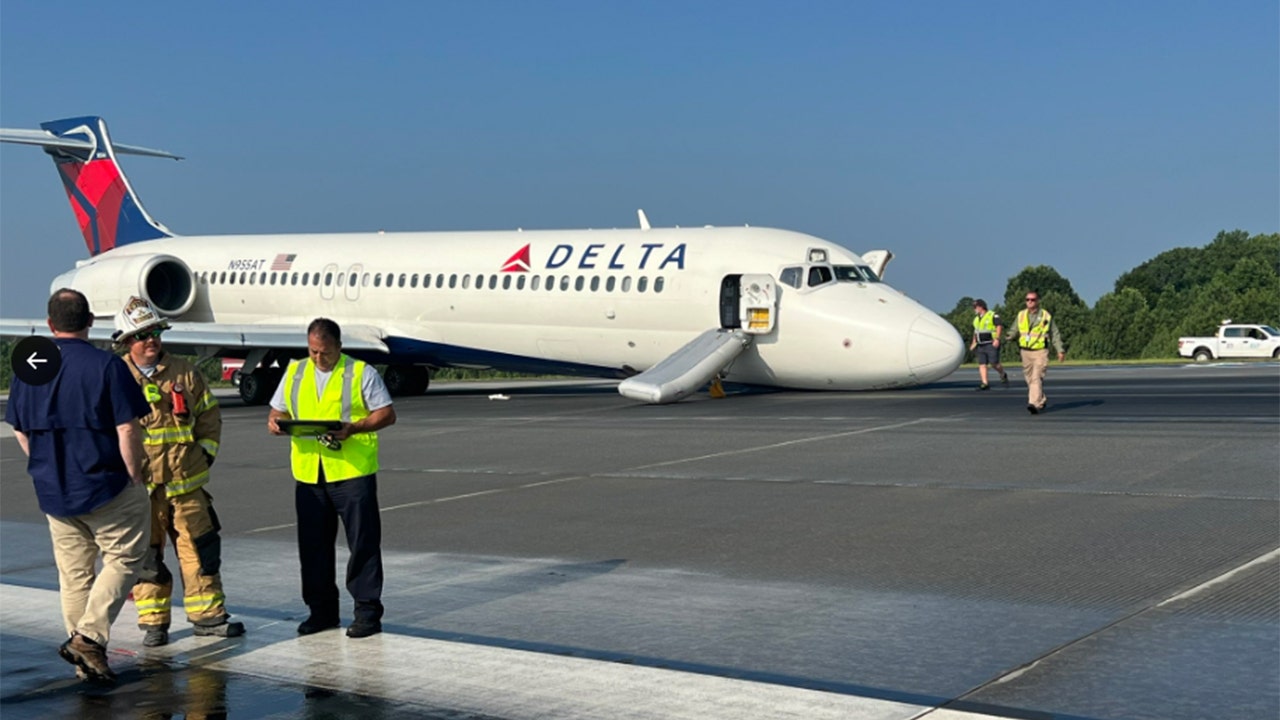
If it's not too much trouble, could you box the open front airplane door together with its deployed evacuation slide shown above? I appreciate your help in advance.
[618,275,778,405]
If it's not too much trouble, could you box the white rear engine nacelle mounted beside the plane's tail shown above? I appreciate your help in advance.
[50,255,196,318]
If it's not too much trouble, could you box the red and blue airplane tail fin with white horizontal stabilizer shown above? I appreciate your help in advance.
[0,117,182,255]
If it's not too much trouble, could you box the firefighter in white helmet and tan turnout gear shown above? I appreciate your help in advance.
[113,297,244,647]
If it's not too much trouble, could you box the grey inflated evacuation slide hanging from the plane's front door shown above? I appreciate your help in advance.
[618,328,751,405]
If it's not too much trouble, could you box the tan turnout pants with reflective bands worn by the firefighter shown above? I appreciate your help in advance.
[133,486,227,629]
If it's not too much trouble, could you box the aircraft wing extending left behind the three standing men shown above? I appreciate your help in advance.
[0,320,387,357]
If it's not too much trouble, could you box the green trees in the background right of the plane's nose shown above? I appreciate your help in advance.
[945,231,1280,360]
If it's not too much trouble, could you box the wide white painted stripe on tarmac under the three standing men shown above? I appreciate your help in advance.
[0,584,936,720]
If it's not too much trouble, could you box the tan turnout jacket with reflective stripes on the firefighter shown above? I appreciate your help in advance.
[124,352,223,497]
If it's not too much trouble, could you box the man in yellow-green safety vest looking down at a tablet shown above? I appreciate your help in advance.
[266,318,396,638]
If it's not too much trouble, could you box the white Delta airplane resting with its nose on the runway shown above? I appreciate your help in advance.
[0,117,964,405]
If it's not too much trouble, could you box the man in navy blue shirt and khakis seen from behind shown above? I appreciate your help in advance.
[5,288,151,682]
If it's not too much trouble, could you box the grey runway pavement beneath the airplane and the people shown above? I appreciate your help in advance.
[0,363,1280,720]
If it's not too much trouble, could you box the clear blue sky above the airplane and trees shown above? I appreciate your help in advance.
[0,0,1280,318]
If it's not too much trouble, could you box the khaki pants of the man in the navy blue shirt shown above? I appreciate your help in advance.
[46,484,150,646]
